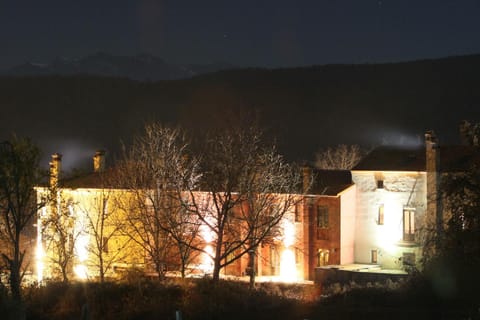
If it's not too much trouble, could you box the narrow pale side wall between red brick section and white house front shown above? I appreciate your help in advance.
[340,185,356,264]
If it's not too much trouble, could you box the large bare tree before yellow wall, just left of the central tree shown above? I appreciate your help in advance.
[119,123,198,277]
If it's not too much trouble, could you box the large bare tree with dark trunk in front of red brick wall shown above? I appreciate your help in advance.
[191,125,299,285]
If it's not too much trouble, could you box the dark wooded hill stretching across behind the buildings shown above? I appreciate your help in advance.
[0,55,480,171]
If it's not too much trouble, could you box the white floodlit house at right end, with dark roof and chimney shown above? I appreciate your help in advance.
[351,132,480,271]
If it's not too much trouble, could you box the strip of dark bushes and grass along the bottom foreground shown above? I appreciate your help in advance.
[0,276,480,320]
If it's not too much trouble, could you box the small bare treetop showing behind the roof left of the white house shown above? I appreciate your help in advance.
[315,144,365,170]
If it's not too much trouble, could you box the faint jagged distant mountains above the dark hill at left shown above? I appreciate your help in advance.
[0,52,233,81]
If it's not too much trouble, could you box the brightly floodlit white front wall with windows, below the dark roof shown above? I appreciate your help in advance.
[352,171,427,269]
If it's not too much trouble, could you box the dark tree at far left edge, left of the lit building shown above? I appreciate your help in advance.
[0,137,46,300]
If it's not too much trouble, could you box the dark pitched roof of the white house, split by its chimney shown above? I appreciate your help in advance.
[352,146,480,172]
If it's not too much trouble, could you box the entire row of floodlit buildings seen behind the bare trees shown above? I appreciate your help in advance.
[37,133,480,281]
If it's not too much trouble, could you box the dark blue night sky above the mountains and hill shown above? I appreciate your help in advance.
[0,0,480,69]
